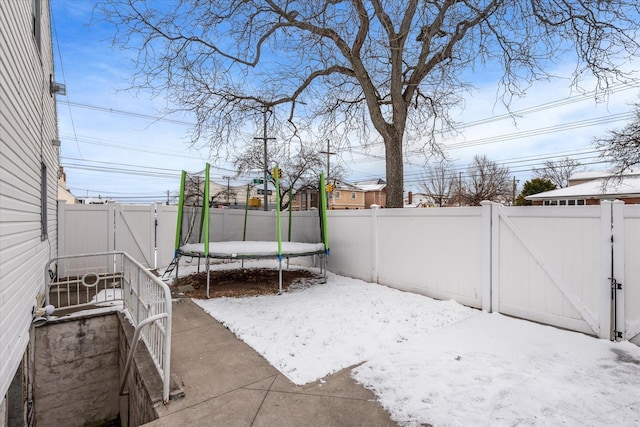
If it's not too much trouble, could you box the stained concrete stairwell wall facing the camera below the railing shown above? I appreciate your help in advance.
[34,314,120,427]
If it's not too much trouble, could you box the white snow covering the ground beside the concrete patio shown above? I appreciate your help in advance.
[190,261,640,426]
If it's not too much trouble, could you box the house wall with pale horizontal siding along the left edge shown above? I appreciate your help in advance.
[0,0,60,426]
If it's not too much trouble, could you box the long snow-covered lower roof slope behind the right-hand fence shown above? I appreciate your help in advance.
[525,173,640,200]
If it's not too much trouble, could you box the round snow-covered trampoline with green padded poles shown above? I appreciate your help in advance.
[165,164,329,298]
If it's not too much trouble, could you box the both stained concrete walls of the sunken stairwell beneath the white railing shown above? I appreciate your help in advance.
[33,311,162,427]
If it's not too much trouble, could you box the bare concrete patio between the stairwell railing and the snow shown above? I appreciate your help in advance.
[145,298,396,427]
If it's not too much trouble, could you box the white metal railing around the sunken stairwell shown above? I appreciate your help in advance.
[45,252,171,403]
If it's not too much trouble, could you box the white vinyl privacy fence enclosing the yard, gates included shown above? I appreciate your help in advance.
[59,201,640,343]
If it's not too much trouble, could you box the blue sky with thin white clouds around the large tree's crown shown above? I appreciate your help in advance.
[51,0,640,202]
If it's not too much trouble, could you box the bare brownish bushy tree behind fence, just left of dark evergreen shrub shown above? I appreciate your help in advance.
[463,155,512,206]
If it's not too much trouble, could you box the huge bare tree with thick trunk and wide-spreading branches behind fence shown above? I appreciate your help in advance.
[99,0,640,207]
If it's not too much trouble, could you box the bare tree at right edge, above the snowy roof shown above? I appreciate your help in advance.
[595,104,640,176]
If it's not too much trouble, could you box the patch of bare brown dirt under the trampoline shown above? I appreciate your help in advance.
[172,268,322,299]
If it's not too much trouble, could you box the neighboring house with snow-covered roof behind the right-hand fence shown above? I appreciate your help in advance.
[526,169,640,206]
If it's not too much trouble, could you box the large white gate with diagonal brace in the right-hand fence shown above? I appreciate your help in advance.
[491,204,611,337]
